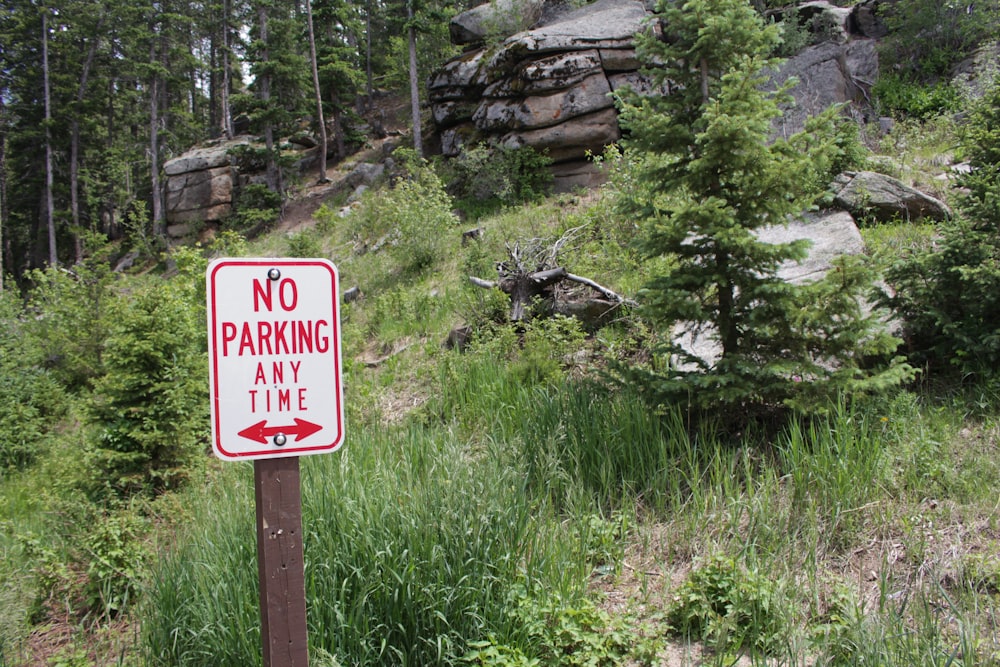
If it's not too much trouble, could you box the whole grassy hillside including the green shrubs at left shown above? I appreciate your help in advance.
[0,115,1000,667]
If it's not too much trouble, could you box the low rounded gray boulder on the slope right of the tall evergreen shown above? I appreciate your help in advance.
[831,171,952,222]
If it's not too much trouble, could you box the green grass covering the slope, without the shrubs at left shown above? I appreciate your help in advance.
[9,145,1000,667]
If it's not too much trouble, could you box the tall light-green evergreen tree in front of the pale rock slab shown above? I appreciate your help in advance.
[623,0,908,418]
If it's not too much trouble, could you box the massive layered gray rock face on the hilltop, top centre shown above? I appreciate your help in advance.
[429,0,650,190]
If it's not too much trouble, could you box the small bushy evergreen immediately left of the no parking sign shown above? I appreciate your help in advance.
[89,283,208,496]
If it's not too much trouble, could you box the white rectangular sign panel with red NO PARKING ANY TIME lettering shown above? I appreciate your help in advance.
[206,259,344,460]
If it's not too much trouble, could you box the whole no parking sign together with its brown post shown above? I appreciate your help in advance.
[205,258,344,667]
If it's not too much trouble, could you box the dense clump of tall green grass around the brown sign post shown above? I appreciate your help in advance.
[144,426,585,665]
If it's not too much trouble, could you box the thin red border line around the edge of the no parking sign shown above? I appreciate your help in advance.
[206,258,344,461]
